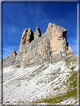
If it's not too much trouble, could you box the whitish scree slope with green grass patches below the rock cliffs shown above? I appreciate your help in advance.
[3,56,78,105]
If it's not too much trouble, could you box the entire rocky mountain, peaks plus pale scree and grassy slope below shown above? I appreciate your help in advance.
[0,23,78,106]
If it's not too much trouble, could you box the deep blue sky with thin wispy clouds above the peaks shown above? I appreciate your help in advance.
[3,2,77,58]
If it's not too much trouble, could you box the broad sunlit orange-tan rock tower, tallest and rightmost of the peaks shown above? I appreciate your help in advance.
[47,23,68,57]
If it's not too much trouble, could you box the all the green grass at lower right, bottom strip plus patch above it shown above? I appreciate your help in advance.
[33,72,77,104]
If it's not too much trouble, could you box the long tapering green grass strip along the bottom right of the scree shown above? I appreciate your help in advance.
[33,88,77,104]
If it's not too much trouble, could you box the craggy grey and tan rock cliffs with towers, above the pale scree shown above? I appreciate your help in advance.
[3,23,74,66]
